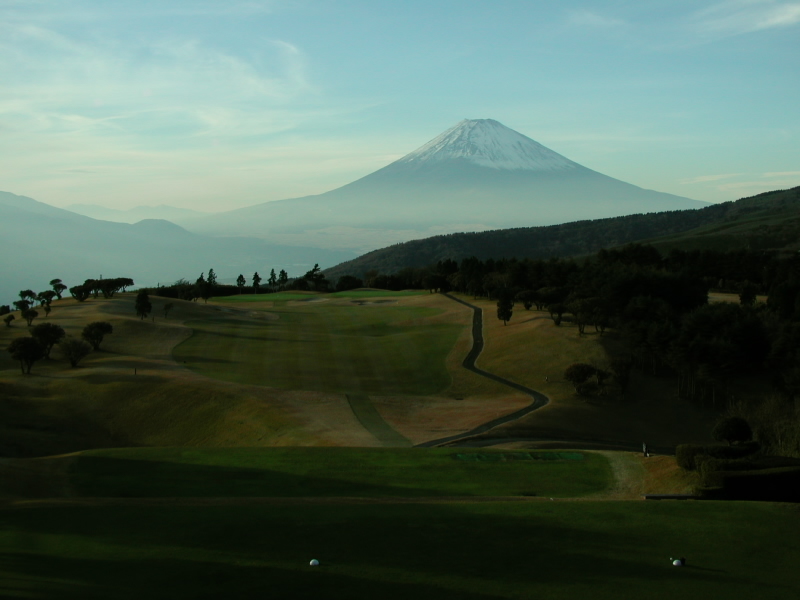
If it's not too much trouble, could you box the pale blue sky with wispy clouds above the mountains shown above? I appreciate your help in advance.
[0,0,800,211]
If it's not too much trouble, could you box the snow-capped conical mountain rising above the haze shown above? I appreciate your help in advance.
[184,119,707,252]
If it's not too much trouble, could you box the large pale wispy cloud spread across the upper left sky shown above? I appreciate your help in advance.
[0,24,317,144]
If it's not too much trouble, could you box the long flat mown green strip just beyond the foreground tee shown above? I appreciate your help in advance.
[69,448,611,497]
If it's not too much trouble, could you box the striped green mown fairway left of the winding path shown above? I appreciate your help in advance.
[174,303,466,395]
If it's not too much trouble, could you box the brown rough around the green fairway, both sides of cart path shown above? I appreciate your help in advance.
[0,293,714,457]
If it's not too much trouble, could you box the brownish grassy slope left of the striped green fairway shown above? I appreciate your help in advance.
[0,295,370,456]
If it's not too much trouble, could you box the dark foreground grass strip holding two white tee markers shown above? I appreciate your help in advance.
[0,501,800,600]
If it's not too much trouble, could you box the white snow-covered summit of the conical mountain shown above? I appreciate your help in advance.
[397,119,579,171]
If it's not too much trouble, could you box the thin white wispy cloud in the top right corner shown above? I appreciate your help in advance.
[691,0,800,37]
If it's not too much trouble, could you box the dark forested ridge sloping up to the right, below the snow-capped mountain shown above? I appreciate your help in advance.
[325,187,800,280]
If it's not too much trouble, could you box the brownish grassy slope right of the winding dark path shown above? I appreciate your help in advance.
[456,296,716,446]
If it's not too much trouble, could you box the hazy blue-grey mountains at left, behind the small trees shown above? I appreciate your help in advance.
[0,192,353,304]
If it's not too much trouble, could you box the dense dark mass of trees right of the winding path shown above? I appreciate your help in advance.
[350,245,800,407]
